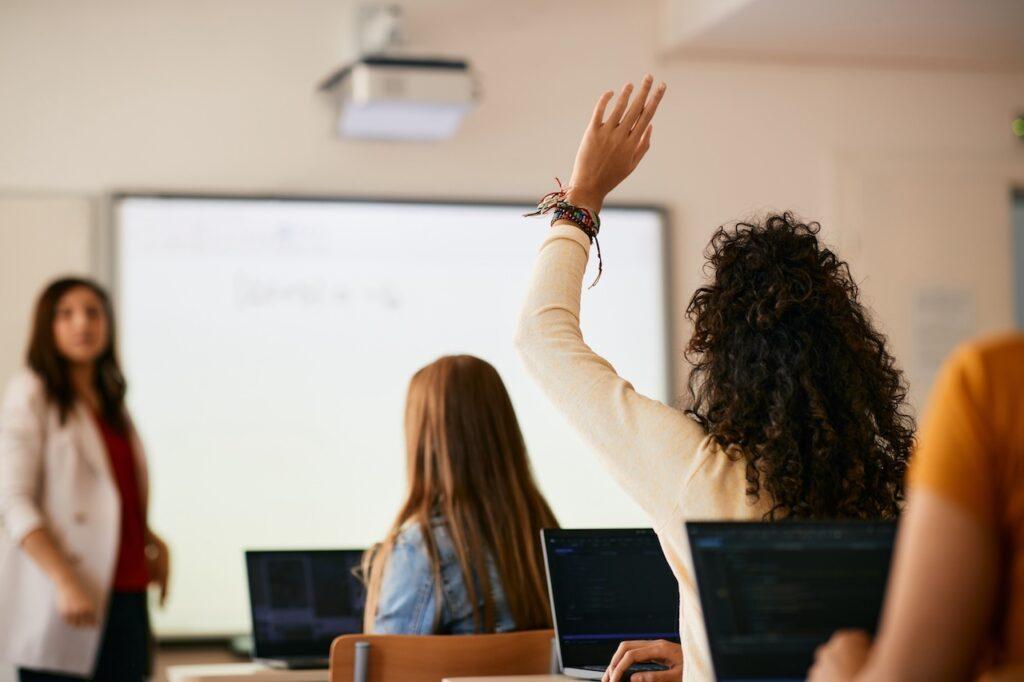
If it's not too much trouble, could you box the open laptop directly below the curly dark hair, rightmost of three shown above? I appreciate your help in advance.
[686,521,896,682]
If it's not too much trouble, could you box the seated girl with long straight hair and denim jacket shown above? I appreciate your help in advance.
[364,355,558,635]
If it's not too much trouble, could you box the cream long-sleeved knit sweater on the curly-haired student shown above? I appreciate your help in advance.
[516,223,769,682]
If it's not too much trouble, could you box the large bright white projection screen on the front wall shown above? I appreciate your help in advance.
[116,197,670,637]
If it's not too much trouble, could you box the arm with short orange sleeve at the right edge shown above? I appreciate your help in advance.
[811,347,1008,682]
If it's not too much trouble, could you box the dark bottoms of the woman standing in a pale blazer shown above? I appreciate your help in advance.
[17,592,150,682]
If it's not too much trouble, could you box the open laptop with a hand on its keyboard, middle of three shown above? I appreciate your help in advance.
[541,528,679,680]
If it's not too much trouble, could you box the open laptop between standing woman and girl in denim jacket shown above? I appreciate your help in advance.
[246,550,366,670]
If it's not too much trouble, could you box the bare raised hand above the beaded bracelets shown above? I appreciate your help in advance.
[566,74,666,211]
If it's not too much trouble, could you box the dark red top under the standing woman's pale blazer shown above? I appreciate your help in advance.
[94,415,150,592]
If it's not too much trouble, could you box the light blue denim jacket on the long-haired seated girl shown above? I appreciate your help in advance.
[374,519,515,635]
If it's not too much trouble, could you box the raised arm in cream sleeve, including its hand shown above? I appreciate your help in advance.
[516,75,705,522]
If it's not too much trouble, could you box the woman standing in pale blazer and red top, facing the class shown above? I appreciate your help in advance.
[0,279,169,681]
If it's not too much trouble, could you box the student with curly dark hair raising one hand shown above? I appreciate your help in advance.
[517,76,913,682]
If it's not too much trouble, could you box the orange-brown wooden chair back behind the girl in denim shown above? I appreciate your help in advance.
[330,630,557,682]
